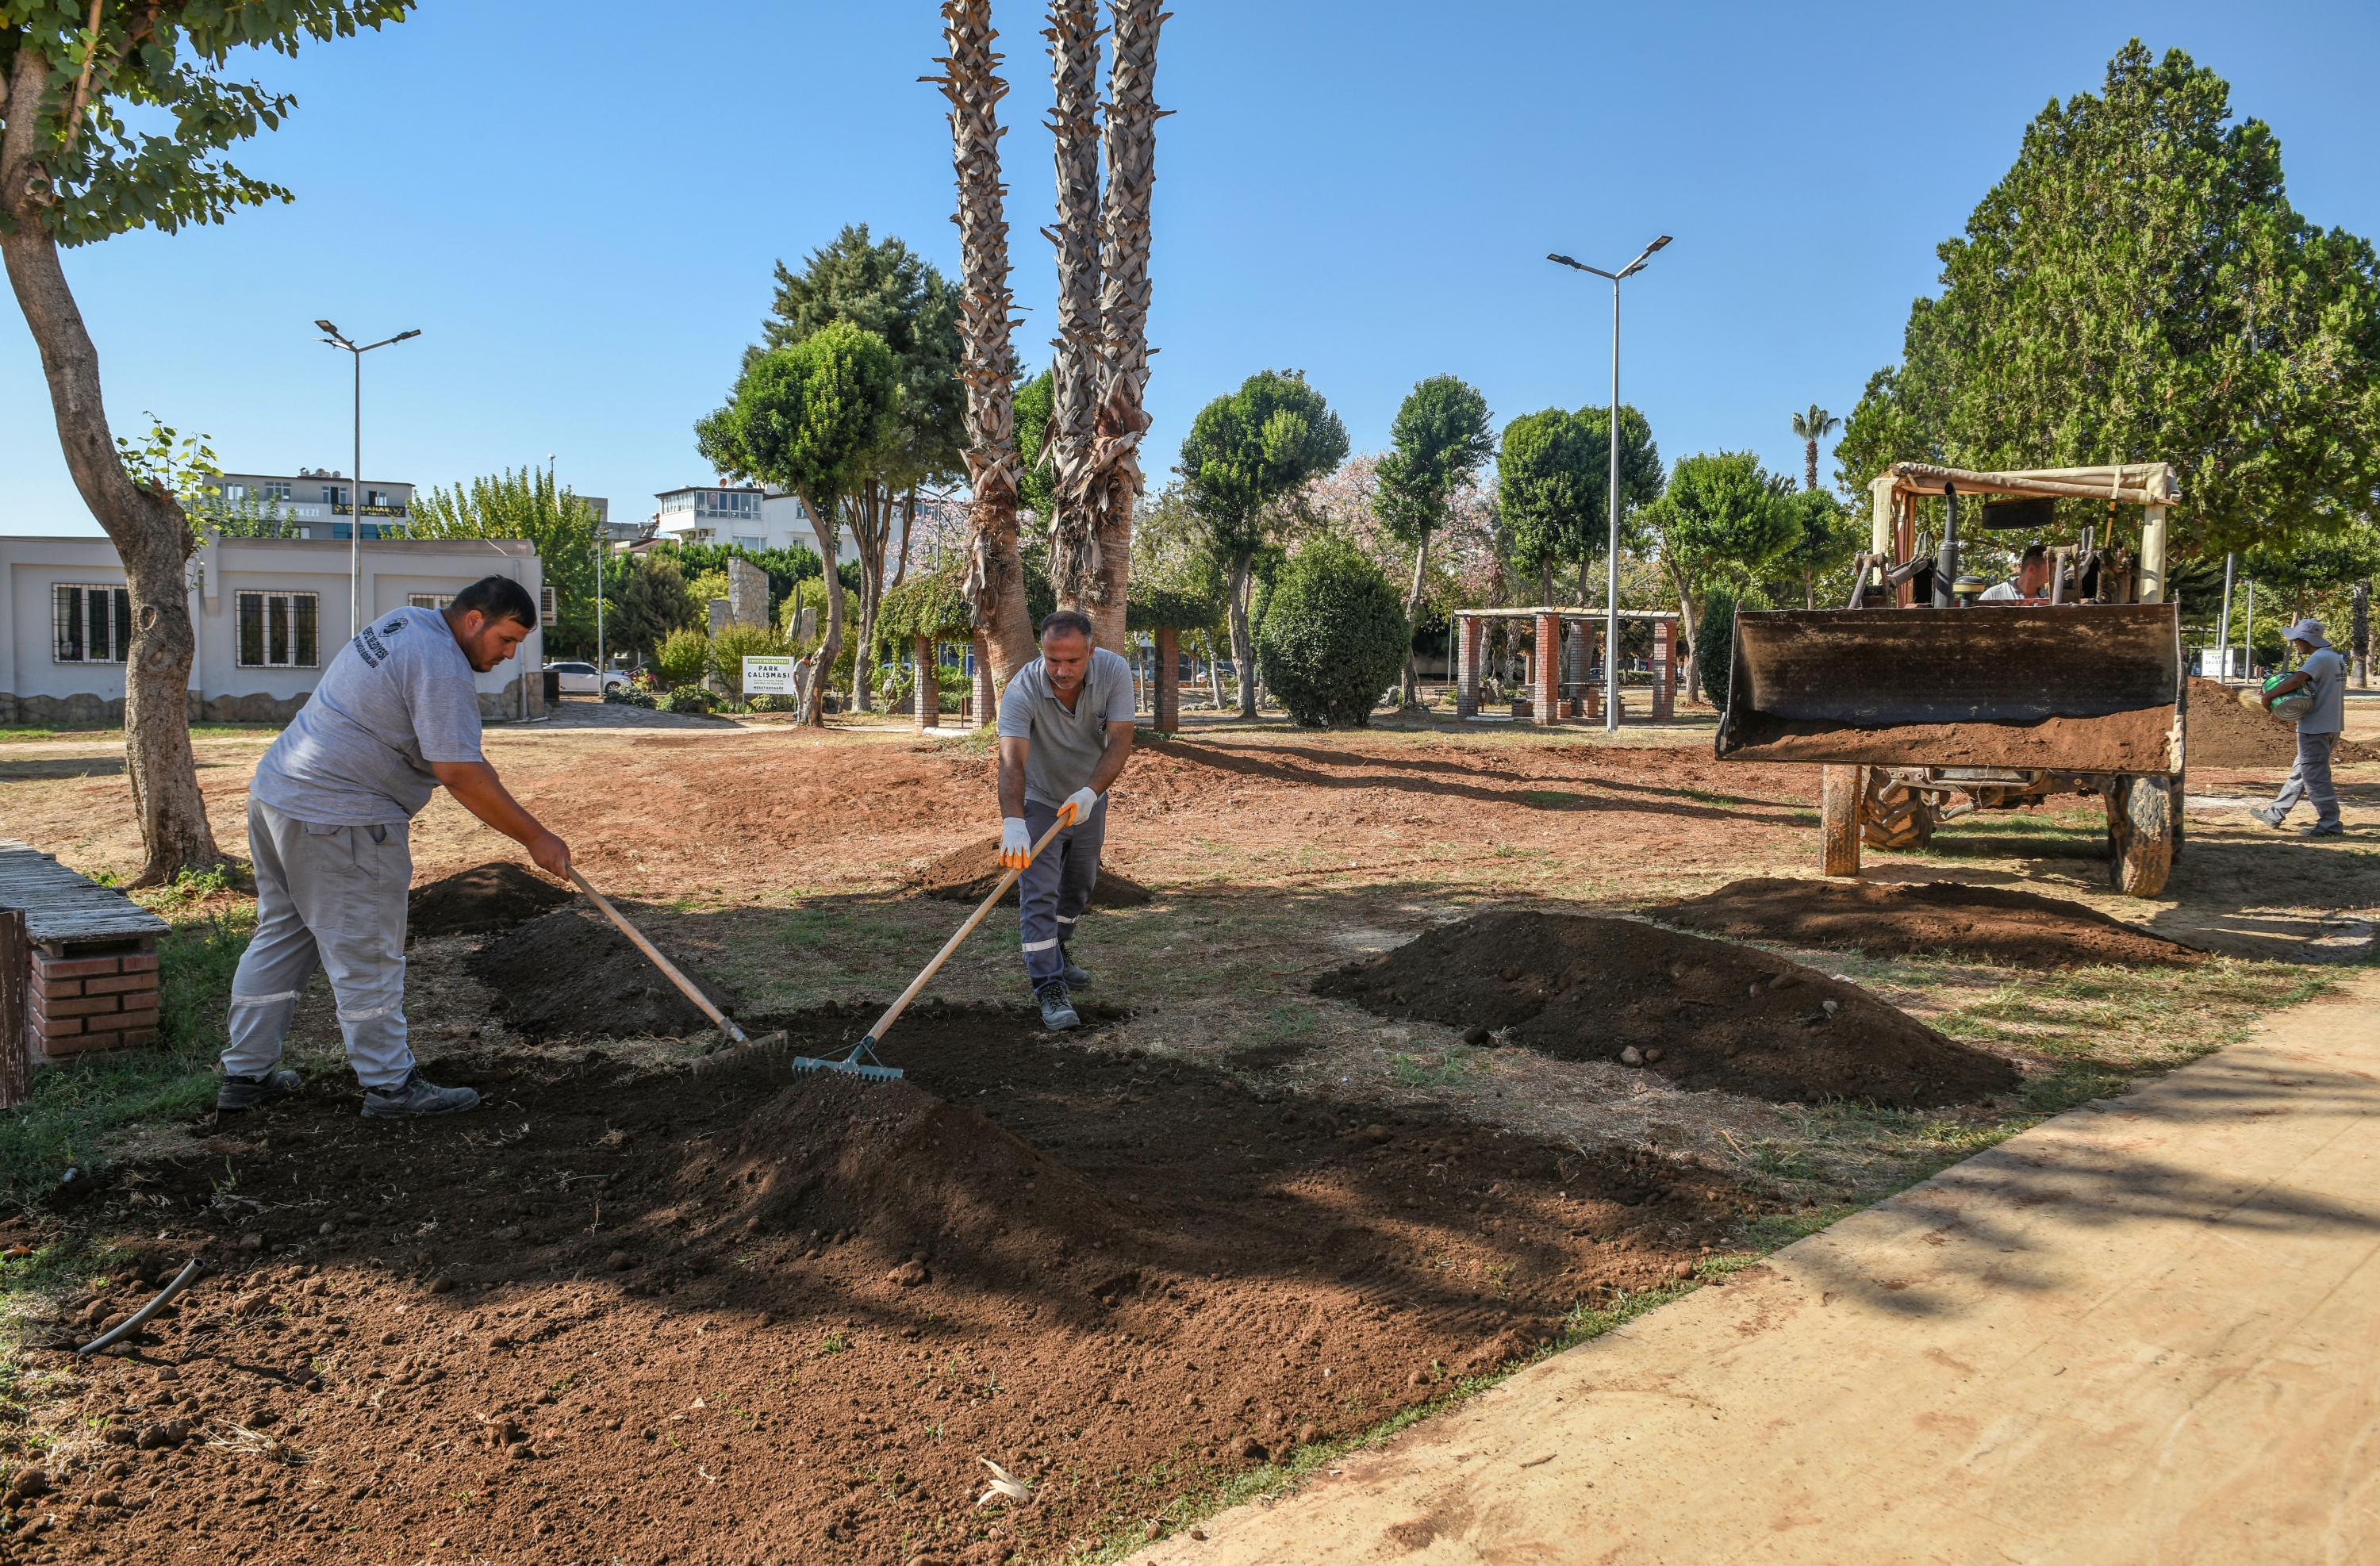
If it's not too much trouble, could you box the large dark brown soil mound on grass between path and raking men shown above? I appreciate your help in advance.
[1314,912,2018,1109]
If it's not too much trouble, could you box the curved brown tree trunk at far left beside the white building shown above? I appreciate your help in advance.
[0,152,224,885]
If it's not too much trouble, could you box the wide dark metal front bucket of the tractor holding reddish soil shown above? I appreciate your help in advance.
[1718,605,2185,773]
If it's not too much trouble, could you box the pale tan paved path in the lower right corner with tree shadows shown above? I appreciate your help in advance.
[1138,971,2380,1566]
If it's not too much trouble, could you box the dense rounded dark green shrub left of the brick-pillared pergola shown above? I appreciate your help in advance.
[1257,538,1411,728]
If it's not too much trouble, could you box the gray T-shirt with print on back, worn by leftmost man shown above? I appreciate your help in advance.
[250,609,478,826]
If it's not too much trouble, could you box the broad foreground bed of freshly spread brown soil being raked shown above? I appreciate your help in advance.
[10,1009,1752,1564]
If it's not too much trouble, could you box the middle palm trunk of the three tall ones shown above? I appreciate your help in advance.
[1042,0,1104,609]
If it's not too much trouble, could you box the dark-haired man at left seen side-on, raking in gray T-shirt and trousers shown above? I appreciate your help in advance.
[214,576,571,1116]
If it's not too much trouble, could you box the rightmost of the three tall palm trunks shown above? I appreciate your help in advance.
[1088,0,1166,650]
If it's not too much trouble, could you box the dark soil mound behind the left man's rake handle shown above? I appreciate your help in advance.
[464,907,738,1038]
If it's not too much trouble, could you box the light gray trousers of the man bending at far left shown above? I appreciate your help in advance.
[224,800,414,1088]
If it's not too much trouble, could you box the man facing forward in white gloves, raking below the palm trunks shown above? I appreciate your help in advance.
[1000,609,1133,1028]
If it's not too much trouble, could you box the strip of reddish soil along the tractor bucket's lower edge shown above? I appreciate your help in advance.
[1728,700,2199,773]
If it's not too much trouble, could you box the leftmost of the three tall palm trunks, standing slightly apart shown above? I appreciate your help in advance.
[926,0,1035,685]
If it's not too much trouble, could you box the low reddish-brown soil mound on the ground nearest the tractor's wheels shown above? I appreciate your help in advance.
[1645,876,2204,969]
